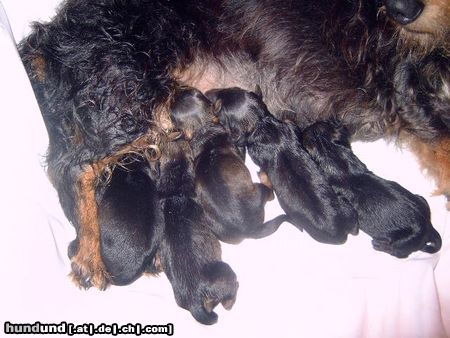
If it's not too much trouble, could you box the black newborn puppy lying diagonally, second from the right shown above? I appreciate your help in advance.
[206,88,357,244]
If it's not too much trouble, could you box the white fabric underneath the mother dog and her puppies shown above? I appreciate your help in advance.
[0,0,450,338]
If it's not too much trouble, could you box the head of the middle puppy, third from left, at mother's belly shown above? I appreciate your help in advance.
[171,87,218,140]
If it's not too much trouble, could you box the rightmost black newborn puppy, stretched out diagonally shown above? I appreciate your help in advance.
[303,122,442,258]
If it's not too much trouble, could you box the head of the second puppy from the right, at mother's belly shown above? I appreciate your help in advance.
[205,87,270,145]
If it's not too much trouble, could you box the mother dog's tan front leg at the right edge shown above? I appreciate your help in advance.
[407,136,450,210]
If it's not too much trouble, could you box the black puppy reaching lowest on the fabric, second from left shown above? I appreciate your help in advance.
[157,140,238,324]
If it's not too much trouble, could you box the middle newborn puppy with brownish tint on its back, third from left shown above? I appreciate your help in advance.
[172,88,286,243]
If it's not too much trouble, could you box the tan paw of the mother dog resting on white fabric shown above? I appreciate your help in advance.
[70,254,110,290]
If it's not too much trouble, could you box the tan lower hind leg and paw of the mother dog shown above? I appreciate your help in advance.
[70,166,109,290]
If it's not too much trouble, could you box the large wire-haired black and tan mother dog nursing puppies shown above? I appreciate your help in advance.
[19,0,450,288]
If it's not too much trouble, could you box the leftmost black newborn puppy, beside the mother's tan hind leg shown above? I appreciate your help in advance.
[97,161,162,285]
